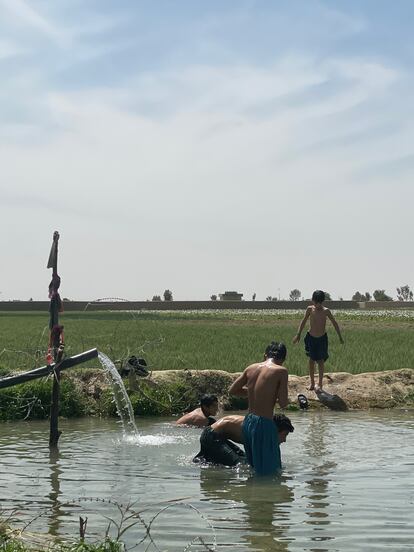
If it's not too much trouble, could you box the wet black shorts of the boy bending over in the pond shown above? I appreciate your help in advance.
[193,427,245,466]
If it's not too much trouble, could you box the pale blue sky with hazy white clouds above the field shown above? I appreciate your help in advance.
[0,0,414,300]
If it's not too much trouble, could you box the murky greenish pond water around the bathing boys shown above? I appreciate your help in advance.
[0,411,414,552]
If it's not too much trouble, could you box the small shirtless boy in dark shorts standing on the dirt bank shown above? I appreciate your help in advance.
[293,289,344,391]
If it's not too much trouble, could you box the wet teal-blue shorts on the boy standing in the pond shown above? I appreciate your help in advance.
[242,414,282,475]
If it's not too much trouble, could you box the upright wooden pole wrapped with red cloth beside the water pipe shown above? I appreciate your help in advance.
[46,232,64,447]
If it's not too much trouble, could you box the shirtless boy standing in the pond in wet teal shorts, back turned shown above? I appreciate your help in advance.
[229,341,288,475]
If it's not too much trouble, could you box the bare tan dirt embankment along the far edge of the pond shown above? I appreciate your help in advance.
[75,368,414,409]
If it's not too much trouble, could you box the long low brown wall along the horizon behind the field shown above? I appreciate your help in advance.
[0,301,414,312]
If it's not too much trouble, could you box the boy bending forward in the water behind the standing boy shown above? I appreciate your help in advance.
[193,414,294,470]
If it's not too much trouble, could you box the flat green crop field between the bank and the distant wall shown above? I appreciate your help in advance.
[0,310,414,376]
